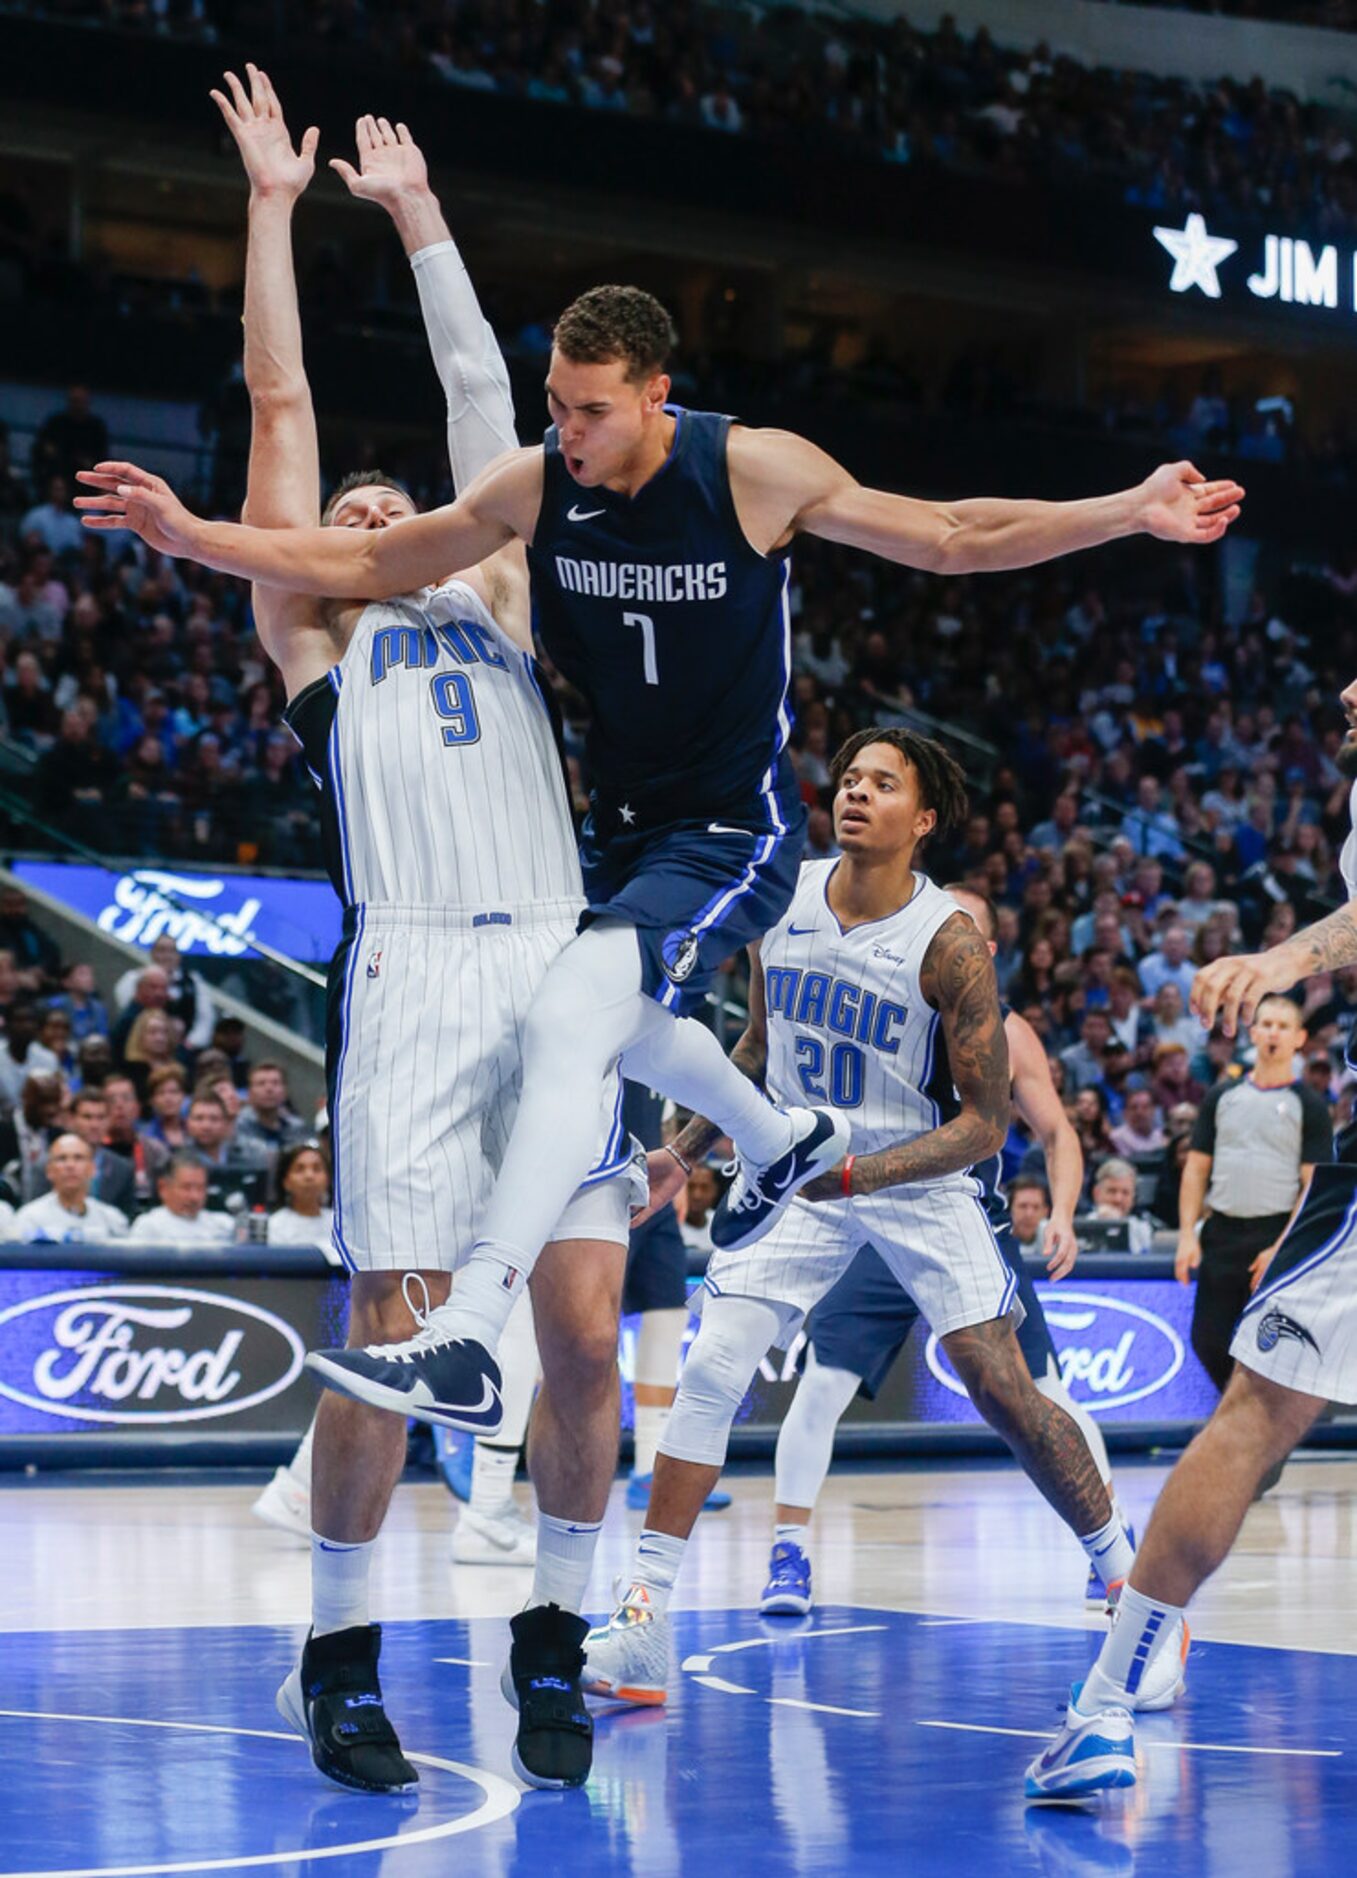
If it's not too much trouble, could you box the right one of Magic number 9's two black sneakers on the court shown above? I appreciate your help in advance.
[499,1604,593,1788]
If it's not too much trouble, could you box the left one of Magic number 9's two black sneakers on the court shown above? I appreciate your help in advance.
[278,1624,419,1793]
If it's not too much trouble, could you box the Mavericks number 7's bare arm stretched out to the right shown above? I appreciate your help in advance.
[730,430,1244,575]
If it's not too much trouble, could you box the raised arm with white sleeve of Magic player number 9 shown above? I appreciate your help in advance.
[330,116,518,492]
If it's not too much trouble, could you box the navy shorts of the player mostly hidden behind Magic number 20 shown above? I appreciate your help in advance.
[807,1226,1059,1401]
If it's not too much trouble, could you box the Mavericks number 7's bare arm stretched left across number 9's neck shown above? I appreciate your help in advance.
[75,447,542,601]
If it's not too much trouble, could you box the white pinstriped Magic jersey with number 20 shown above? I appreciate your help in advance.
[760,860,959,1156]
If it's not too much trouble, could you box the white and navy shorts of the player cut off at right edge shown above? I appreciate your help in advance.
[1229,1161,1357,1403]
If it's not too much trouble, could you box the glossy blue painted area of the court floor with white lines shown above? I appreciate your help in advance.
[0,1608,1357,1878]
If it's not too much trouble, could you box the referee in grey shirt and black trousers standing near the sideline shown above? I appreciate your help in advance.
[1173,995,1333,1390]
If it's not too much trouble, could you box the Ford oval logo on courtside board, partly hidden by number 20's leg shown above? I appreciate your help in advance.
[927,1285,1184,1414]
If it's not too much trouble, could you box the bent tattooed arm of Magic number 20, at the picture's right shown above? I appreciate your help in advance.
[801,913,1008,1200]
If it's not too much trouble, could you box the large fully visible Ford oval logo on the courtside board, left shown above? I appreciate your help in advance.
[0,1285,306,1425]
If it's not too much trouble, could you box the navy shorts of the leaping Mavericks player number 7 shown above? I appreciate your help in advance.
[580,802,805,1016]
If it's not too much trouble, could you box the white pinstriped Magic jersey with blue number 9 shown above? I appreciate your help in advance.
[285,580,584,915]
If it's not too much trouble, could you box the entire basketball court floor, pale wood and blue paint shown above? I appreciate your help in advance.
[0,1454,1357,1878]
